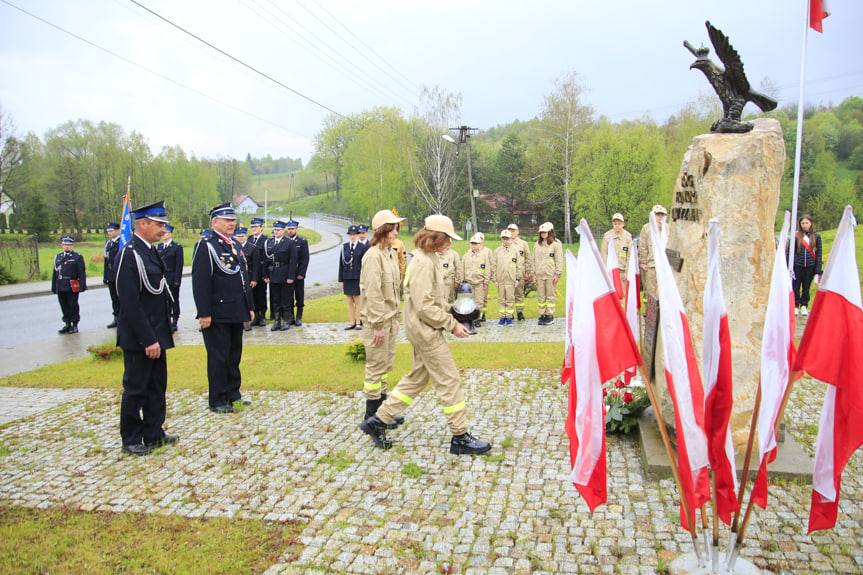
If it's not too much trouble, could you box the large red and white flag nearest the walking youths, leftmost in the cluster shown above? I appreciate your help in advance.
[566,219,641,512]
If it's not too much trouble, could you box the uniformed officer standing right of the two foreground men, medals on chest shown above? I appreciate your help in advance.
[192,202,255,413]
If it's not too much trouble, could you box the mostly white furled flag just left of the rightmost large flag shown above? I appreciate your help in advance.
[751,211,796,509]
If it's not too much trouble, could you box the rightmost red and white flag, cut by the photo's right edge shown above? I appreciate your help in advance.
[794,206,863,533]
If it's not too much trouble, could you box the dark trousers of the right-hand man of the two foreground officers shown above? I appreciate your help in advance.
[203,323,243,407]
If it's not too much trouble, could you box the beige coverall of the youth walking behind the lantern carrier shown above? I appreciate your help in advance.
[360,246,401,400]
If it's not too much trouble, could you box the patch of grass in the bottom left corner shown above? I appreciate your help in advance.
[0,506,304,575]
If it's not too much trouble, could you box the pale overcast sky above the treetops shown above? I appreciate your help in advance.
[0,0,863,162]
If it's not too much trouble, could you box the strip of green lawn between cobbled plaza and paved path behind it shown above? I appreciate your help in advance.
[0,341,563,393]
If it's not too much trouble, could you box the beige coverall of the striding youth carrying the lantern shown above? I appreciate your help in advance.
[377,250,468,436]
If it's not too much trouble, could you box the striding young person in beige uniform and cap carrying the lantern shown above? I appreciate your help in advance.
[360,214,491,455]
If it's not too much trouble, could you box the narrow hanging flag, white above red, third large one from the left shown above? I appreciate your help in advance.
[701,218,740,525]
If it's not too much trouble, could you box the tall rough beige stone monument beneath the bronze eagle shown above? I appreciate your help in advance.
[656,118,785,452]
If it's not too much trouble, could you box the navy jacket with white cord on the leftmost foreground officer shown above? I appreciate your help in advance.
[117,234,174,351]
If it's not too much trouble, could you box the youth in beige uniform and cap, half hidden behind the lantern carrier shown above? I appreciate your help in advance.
[360,210,404,425]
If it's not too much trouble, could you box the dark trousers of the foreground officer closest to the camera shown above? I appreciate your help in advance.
[120,350,168,445]
